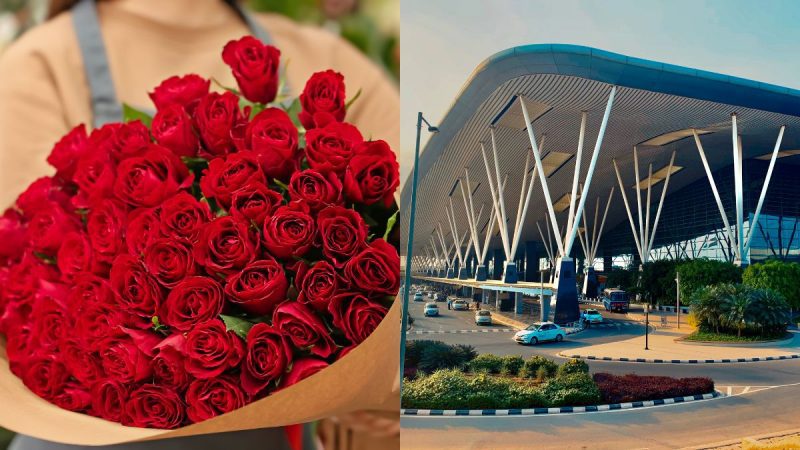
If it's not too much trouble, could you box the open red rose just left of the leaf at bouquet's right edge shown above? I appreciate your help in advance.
[317,206,368,270]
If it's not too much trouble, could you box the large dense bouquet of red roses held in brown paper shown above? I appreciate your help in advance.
[0,37,400,443]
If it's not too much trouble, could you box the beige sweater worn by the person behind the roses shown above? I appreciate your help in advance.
[0,0,400,207]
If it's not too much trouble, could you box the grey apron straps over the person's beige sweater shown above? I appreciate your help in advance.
[72,0,288,128]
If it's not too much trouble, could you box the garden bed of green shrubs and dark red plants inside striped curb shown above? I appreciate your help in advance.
[401,341,714,409]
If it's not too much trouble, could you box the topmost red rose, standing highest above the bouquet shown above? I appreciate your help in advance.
[222,36,281,104]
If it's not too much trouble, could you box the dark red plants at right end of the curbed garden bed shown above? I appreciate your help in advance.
[594,373,714,403]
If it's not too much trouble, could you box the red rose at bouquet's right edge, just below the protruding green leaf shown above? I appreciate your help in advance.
[344,239,400,295]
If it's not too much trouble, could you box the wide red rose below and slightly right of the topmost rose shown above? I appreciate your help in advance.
[237,108,299,180]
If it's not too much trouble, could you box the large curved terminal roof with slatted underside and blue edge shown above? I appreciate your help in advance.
[401,44,800,255]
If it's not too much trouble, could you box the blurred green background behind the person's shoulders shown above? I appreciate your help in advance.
[0,0,400,450]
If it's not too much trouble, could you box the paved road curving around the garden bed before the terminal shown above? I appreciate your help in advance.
[402,303,800,449]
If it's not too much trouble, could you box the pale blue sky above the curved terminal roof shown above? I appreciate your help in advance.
[400,0,800,183]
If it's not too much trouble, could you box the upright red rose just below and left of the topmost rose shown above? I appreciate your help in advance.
[194,91,244,156]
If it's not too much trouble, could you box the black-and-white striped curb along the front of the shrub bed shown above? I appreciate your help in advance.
[400,391,723,416]
